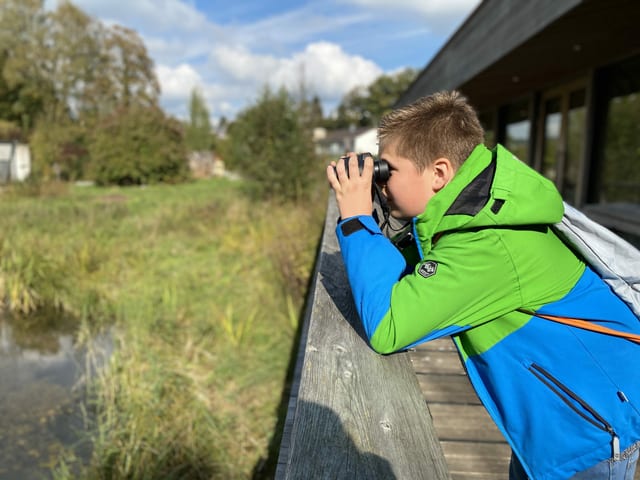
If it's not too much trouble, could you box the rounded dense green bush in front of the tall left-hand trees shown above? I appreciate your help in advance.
[89,105,187,185]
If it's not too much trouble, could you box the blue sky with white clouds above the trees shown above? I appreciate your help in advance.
[45,0,480,123]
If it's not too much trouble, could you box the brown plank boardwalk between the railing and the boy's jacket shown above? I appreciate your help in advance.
[410,337,511,480]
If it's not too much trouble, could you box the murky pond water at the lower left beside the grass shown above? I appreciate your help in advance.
[0,312,112,480]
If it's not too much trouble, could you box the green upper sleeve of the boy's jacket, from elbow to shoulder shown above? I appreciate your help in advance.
[370,230,522,353]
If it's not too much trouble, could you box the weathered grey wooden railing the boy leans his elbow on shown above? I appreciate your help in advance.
[276,195,450,480]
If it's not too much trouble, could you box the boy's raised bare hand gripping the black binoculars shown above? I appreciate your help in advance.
[327,152,373,218]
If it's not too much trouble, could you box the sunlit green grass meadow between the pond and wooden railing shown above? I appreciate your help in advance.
[0,180,325,479]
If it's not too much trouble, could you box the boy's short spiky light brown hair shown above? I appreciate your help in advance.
[378,90,484,171]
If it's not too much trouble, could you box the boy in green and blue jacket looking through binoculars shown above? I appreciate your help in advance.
[327,92,640,480]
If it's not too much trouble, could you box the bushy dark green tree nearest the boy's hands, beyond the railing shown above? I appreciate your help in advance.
[224,87,315,200]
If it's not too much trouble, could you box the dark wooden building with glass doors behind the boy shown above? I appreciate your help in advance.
[396,0,640,244]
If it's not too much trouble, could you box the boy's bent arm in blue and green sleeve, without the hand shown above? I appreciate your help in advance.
[337,224,521,353]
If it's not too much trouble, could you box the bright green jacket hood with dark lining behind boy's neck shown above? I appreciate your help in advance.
[415,145,564,250]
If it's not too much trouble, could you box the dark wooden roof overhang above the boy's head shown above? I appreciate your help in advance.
[396,0,640,110]
